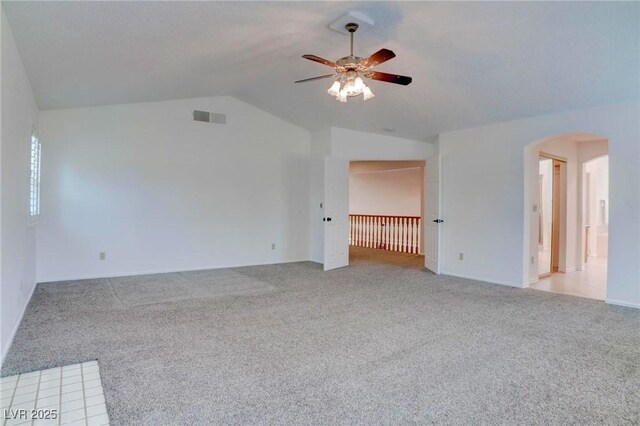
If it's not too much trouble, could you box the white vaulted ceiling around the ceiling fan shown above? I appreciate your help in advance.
[3,1,640,140]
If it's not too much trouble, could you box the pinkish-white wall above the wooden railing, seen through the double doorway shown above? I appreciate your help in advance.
[349,167,422,216]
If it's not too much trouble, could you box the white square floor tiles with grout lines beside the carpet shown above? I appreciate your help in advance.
[0,361,109,426]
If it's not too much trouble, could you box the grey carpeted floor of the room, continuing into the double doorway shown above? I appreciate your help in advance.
[2,248,640,425]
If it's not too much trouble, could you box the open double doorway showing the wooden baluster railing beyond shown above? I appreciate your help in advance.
[349,161,425,269]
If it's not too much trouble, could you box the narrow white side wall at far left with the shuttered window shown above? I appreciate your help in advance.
[0,8,40,361]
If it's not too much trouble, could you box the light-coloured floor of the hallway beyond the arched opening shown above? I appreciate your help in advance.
[529,257,607,300]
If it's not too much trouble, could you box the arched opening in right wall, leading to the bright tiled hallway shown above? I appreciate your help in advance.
[524,133,608,300]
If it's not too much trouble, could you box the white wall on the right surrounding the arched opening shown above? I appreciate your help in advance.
[439,101,640,307]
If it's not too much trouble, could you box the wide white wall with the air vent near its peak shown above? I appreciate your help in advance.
[38,97,310,281]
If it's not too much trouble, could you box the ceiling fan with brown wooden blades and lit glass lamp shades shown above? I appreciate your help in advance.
[296,23,411,102]
